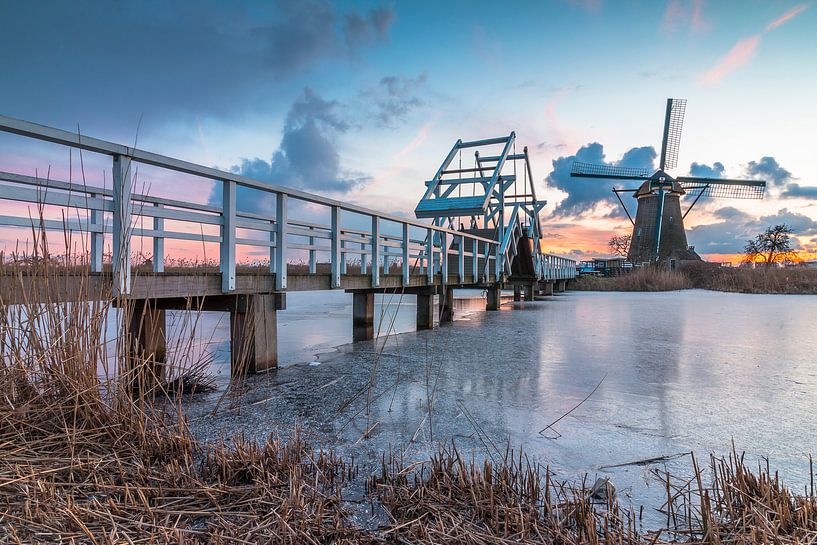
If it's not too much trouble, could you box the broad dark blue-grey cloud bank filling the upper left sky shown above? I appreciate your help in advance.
[0,0,393,128]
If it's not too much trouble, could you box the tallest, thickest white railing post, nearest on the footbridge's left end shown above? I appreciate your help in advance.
[112,155,131,295]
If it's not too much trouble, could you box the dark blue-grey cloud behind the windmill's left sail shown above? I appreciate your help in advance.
[546,142,657,217]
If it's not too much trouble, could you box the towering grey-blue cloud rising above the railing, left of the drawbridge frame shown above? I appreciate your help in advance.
[210,87,369,213]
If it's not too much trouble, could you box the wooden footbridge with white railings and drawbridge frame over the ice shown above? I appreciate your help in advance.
[0,116,576,372]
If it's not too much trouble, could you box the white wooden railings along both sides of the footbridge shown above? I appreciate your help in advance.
[0,116,575,294]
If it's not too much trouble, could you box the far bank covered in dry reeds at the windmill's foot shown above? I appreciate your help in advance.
[573,266,817,295]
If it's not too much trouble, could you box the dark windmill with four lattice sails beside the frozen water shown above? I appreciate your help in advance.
[570,98,766,263]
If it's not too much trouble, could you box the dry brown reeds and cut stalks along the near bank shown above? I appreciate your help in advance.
[0,236,817,545]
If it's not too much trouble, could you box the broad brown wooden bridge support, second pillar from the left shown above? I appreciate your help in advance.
[230,294,278,376]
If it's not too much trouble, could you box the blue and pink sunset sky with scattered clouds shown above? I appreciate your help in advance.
[0,0,817,261]
